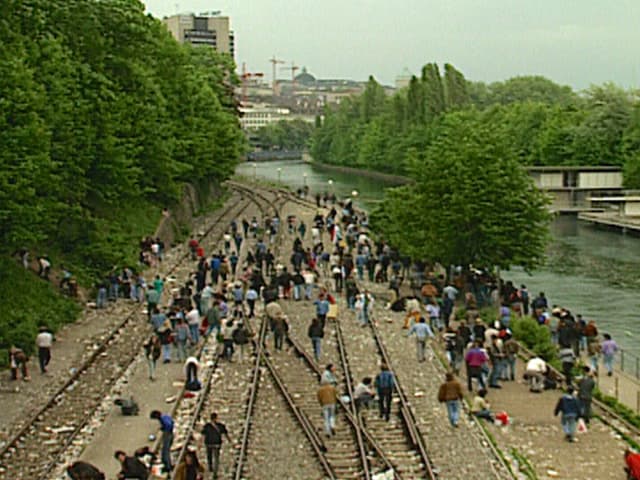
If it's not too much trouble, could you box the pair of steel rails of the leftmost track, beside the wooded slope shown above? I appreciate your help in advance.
[0,191,246,480]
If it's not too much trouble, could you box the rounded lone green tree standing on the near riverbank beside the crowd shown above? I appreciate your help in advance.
[371,111,550,269]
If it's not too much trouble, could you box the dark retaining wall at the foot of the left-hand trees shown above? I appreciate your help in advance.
[154,181,223,247]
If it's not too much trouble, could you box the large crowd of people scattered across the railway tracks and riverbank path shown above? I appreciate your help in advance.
[11,188,618,480]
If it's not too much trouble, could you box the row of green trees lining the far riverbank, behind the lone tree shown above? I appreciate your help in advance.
[311,64,640,181]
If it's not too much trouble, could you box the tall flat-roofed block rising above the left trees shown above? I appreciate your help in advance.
[163,14,235,57]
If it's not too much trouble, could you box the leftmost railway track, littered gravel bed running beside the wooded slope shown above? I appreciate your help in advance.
[0,189,254,480]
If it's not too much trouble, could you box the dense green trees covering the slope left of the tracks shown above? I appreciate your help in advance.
[0,0,242,270]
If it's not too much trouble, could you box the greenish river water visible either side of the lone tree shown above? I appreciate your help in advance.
[237,162,640,355]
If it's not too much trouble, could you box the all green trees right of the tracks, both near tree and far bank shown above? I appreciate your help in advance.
[311,63,640,268]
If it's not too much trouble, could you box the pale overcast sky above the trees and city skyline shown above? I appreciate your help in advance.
[143,0,640,89]
